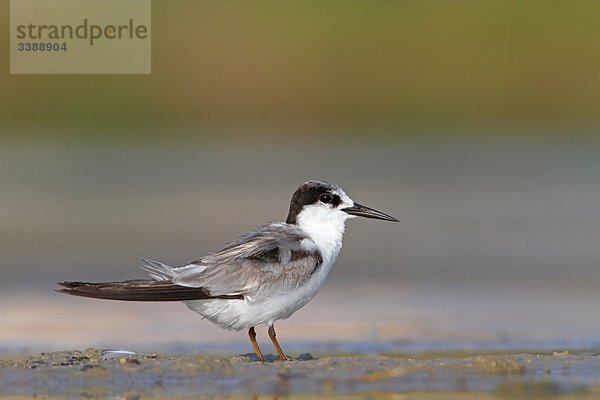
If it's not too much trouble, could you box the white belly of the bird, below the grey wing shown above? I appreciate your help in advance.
[186,265,331,331]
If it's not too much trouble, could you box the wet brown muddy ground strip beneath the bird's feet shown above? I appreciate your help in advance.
[0,349,600,399]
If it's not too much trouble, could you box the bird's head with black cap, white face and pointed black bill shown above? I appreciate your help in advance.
[286,180,398,226]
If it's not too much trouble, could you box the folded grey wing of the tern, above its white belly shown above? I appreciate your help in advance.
[173,224,323,296]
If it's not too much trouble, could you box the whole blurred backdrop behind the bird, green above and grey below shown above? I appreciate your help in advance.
[0,0,600,350]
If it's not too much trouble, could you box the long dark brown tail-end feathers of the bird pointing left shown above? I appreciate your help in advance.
[57,280,244,301]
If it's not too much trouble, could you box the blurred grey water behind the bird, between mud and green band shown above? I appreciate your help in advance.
[0,137,600,347]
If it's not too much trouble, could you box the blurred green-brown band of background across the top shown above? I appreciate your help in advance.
[0,0,600,139]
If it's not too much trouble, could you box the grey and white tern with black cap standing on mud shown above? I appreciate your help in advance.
[57,180,398,362]
